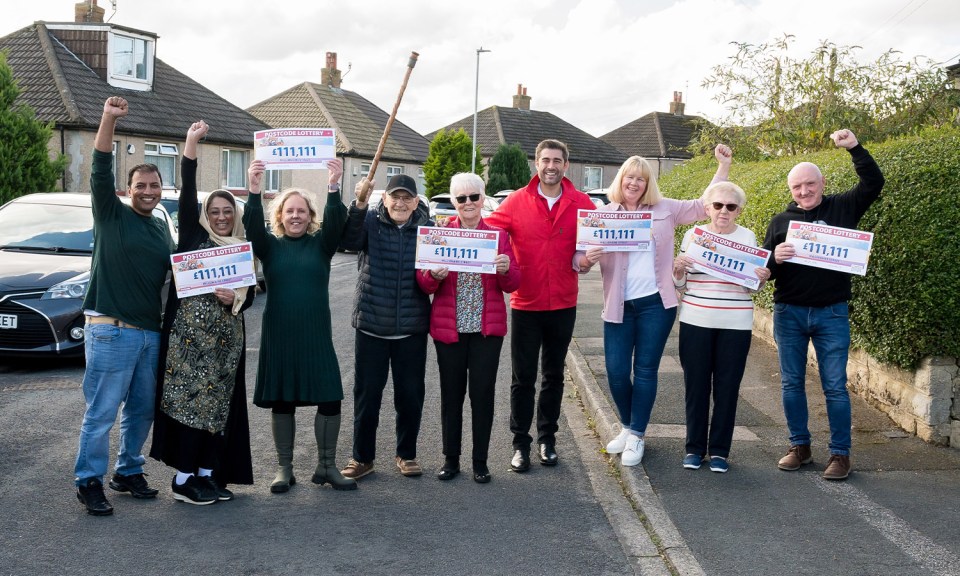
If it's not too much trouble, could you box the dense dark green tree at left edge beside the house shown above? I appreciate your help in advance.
[0,52,67,204]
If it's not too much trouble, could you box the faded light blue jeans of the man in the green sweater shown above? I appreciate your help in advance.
[74,324,160,485]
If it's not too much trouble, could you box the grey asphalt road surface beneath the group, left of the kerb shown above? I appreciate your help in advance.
[0,254,634,575]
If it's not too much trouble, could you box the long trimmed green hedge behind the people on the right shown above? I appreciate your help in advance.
[659,128,960,370]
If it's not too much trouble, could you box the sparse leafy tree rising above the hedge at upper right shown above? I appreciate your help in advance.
[694,35,957,157]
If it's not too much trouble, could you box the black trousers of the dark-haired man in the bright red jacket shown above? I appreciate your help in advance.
[510,307,577,450]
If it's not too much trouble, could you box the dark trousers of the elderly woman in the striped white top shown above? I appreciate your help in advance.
[680,322,751,458]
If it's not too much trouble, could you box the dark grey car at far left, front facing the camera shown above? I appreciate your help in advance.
[0,192,176,356]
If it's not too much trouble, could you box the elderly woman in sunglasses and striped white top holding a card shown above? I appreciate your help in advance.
[673,182,770,472]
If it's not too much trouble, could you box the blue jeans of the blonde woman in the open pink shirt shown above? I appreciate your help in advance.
[603,293,677,436]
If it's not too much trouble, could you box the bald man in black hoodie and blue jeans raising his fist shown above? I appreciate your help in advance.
[763,130,884,480]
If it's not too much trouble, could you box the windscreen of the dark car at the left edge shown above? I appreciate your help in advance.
[0,202,93,252]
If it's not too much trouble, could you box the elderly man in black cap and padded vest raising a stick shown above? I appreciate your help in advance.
[340,174,432,479]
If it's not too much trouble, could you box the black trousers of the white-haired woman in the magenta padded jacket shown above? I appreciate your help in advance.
[434,332,503,462]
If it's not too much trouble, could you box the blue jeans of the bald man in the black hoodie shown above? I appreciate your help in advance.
[773,302,851,456]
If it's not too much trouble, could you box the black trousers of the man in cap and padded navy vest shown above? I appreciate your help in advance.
[353,330,427,463]
